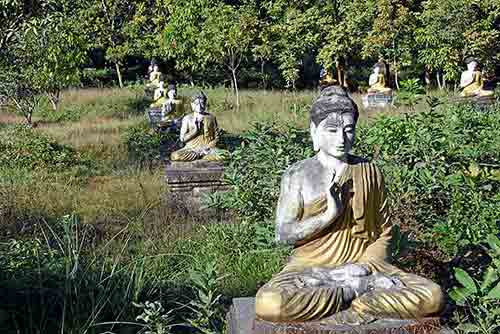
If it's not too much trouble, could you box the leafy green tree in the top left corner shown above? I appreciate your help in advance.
[0,0,86,124]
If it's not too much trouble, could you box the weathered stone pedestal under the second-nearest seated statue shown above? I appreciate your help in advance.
[165,160,229,213]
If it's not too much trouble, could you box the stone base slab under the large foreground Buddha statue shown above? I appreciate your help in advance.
[227,298,444,334]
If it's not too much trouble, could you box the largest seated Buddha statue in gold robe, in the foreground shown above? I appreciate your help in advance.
[256,86,444,325]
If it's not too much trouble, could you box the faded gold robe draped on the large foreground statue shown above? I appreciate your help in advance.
[256,162,443,323]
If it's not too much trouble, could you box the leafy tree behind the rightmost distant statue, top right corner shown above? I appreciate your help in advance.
[416,0,500,88]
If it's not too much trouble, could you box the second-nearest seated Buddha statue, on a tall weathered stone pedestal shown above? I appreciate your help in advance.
[170,92,225,161]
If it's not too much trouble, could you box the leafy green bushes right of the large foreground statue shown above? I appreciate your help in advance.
[358,105,500,255]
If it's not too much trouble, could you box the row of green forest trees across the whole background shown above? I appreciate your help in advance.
[0,0,500,115]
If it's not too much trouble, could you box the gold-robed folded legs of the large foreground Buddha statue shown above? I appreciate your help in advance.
[256,264,443,324]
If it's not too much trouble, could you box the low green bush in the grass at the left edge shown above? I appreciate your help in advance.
[0,126,90,171]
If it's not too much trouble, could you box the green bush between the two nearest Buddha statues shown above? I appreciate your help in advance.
[210,123,313,222]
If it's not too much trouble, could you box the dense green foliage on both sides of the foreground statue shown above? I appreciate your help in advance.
[212,105,500,256]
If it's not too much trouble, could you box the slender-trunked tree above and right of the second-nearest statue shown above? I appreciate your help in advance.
[201,4,258,108]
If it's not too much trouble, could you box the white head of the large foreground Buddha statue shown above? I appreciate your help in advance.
[310,86,359,160]
